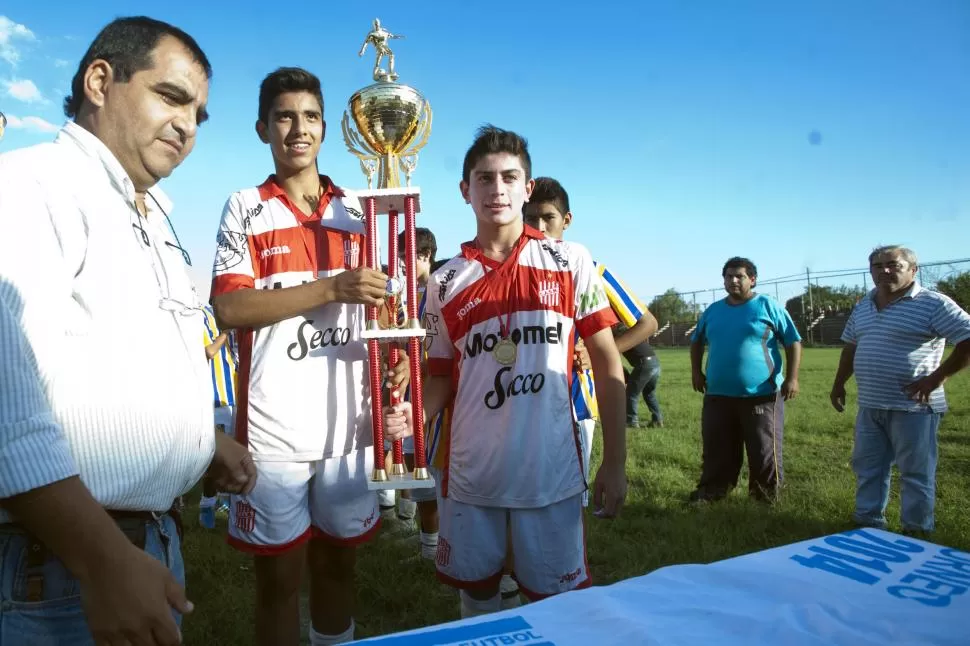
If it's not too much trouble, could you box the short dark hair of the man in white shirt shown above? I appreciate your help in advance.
[64,16,212,119]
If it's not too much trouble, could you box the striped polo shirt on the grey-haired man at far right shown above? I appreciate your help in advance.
[842,283,970,413]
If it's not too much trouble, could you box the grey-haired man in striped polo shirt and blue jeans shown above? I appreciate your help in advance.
[831,246,970,533]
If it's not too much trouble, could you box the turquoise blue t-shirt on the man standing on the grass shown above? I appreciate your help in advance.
[691,294,802,397]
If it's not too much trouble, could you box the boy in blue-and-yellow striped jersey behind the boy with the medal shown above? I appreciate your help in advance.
[524,177,659,486]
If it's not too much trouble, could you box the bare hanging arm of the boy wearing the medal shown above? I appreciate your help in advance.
[585,328,627,517]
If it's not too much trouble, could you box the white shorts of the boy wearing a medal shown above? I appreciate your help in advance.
[437,494,592,601]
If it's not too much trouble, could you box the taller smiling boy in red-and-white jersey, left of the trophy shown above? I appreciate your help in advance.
[212,68,408,646]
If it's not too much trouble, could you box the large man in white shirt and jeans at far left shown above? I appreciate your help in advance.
[0,17,256,646]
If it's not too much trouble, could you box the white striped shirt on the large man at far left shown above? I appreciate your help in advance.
[0,123,215,523]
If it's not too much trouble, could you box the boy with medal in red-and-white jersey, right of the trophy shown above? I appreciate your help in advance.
[387,126,626,617]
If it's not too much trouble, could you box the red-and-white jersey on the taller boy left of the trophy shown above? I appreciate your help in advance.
[212,176,373,461]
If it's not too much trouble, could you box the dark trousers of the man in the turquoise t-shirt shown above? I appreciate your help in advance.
[697,393,785,500]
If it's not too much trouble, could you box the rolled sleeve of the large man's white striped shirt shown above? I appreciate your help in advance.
[0,290,78,499]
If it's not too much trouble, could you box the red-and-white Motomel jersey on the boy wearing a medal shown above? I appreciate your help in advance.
[425,226,616,508]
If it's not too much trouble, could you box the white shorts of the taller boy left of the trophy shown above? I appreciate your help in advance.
[228,448,380,555]
